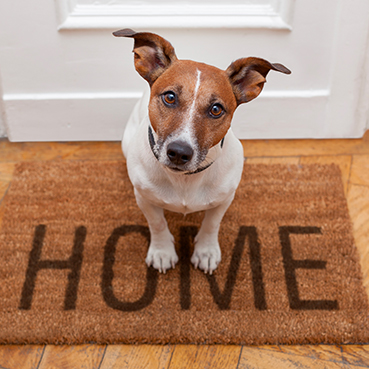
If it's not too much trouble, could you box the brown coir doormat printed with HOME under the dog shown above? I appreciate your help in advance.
[0,162,369,344]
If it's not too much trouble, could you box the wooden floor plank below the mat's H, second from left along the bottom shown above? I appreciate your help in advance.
[39,345,106,369]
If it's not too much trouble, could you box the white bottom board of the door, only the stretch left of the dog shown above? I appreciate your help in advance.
[4,92,141,141]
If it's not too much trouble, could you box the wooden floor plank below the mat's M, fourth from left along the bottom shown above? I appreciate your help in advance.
[169,345,242,369]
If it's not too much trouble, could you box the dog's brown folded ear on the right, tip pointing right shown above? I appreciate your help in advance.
[226,57,291,104]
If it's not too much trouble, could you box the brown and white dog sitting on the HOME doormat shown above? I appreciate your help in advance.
[113,29,291,274]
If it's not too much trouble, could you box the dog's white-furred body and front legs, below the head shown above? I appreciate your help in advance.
[122,85,244,273]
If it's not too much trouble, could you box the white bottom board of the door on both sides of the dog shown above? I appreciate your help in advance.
[4,90,363,141]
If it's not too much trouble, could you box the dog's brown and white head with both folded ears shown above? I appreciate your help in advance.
[113,29,291,173]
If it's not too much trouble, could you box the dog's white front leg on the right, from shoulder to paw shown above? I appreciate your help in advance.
[191,194,234,274]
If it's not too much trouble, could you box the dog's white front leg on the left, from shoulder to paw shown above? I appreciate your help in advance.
[135,190,178,273]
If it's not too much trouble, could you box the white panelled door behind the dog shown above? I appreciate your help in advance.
[0,0,369,141]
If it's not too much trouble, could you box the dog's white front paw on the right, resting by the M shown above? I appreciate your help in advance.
[191,242,222,275]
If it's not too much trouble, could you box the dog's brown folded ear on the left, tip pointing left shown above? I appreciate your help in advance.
[113,28,177,86]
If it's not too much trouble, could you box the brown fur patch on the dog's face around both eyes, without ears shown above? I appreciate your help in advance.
[149,60,237,150]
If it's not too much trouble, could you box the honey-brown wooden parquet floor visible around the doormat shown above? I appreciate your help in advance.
[0,134,369,369]
